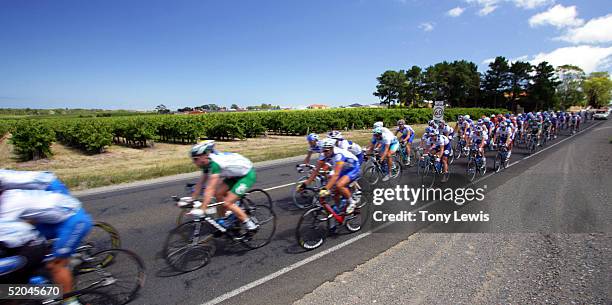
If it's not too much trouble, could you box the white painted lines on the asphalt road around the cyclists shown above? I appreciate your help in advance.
[201,121,594,305]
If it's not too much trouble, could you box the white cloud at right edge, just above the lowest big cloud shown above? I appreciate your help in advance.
[556,14,612,44]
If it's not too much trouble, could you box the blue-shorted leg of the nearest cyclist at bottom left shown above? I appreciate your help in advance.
[47,209,93,293]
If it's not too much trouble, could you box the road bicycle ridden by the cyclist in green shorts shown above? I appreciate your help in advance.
[163,191,276,272]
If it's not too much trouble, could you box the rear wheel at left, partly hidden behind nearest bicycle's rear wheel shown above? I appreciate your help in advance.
[76,221,121,272]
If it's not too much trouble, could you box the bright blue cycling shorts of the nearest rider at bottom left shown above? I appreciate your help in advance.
[36,209,93,258]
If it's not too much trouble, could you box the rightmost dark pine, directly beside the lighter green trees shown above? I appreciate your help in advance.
[528,61,561,111]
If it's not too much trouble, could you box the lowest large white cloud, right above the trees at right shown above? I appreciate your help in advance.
[530,45,612,73]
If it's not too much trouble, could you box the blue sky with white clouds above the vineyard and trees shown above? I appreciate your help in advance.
[0,0,612,110]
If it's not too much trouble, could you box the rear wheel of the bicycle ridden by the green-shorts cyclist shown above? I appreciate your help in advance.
[240,198,276,249]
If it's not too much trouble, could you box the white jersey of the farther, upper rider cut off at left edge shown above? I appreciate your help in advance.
[0,169,57,190]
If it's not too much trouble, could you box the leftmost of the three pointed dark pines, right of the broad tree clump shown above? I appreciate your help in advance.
[482,56,510,108]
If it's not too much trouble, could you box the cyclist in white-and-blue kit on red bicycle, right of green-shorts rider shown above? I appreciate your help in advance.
[297,139,360,214]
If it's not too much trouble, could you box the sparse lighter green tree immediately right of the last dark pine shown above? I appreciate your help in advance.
[556,65,586,109]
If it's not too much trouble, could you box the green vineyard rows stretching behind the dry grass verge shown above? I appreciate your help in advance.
[0,108,505,160]
